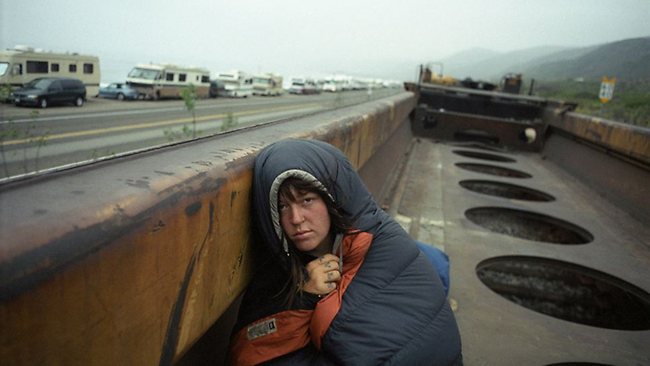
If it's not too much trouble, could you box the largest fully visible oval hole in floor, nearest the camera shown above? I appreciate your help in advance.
[476,256,650,330]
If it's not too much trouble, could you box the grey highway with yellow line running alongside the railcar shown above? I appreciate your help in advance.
[0,89,401,181]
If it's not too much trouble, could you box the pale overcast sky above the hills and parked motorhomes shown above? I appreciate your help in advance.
[0,0,650,81]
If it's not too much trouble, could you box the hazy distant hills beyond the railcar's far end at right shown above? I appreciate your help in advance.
[442,37,650,81]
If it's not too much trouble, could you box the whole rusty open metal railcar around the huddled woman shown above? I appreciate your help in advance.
[0,76,650,365]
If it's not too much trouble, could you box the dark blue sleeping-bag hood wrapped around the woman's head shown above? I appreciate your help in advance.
[253,139,387,268]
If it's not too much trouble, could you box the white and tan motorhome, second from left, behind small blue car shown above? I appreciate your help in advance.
[126,64,210,100]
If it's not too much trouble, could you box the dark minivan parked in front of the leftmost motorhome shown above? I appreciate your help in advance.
[12,78,86,108]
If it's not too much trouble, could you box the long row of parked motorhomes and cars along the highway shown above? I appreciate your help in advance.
[0,46,399,108]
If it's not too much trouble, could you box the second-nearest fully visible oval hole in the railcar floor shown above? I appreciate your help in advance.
[465,207,594,244]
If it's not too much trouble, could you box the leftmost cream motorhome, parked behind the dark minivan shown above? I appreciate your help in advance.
[0,46,100,95]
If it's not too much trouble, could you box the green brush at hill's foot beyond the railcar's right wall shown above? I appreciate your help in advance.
[534,80,650,128]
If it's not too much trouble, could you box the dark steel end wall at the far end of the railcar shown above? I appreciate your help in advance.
[407,84,575,151]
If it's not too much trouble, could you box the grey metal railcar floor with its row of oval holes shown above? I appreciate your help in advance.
[390,138,650,365]
